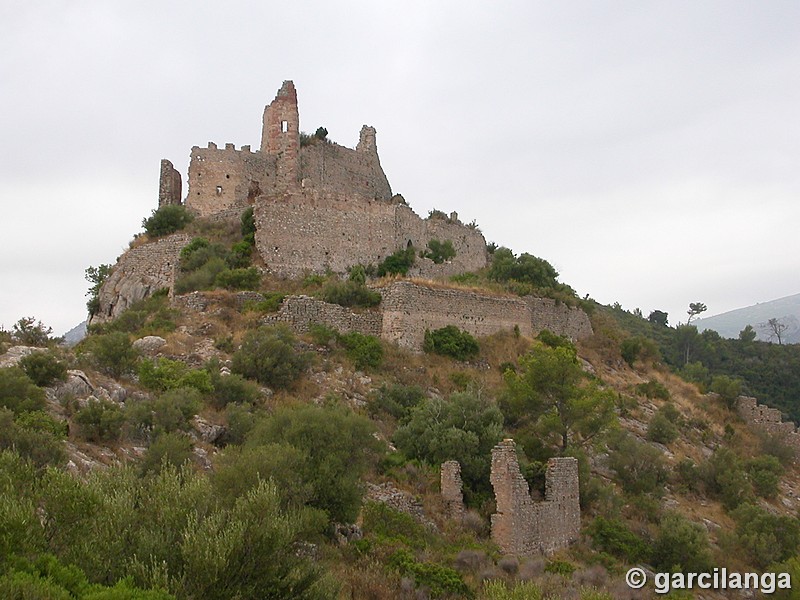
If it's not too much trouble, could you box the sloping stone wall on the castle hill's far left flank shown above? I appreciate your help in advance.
[90,233,191,324]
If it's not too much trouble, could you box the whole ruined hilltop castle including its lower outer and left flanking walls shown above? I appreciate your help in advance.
[92,81,592,350]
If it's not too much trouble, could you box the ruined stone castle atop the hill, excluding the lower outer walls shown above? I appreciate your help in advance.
[159,81,487,278]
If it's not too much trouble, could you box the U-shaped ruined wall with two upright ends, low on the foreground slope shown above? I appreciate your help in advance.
[491,439,580,555]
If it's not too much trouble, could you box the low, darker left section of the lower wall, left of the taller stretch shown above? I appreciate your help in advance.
[264,296,381,337]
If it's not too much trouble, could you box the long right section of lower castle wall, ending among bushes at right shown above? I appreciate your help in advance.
[380,281,592,350]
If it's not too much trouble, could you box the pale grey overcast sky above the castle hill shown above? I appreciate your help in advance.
[0,0,800,333]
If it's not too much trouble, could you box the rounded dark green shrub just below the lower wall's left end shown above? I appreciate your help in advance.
[232,327,310,388]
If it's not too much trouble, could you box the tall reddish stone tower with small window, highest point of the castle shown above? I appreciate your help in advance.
[261,81,300,190]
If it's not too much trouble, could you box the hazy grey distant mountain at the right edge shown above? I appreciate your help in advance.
[693,294,800,344]
